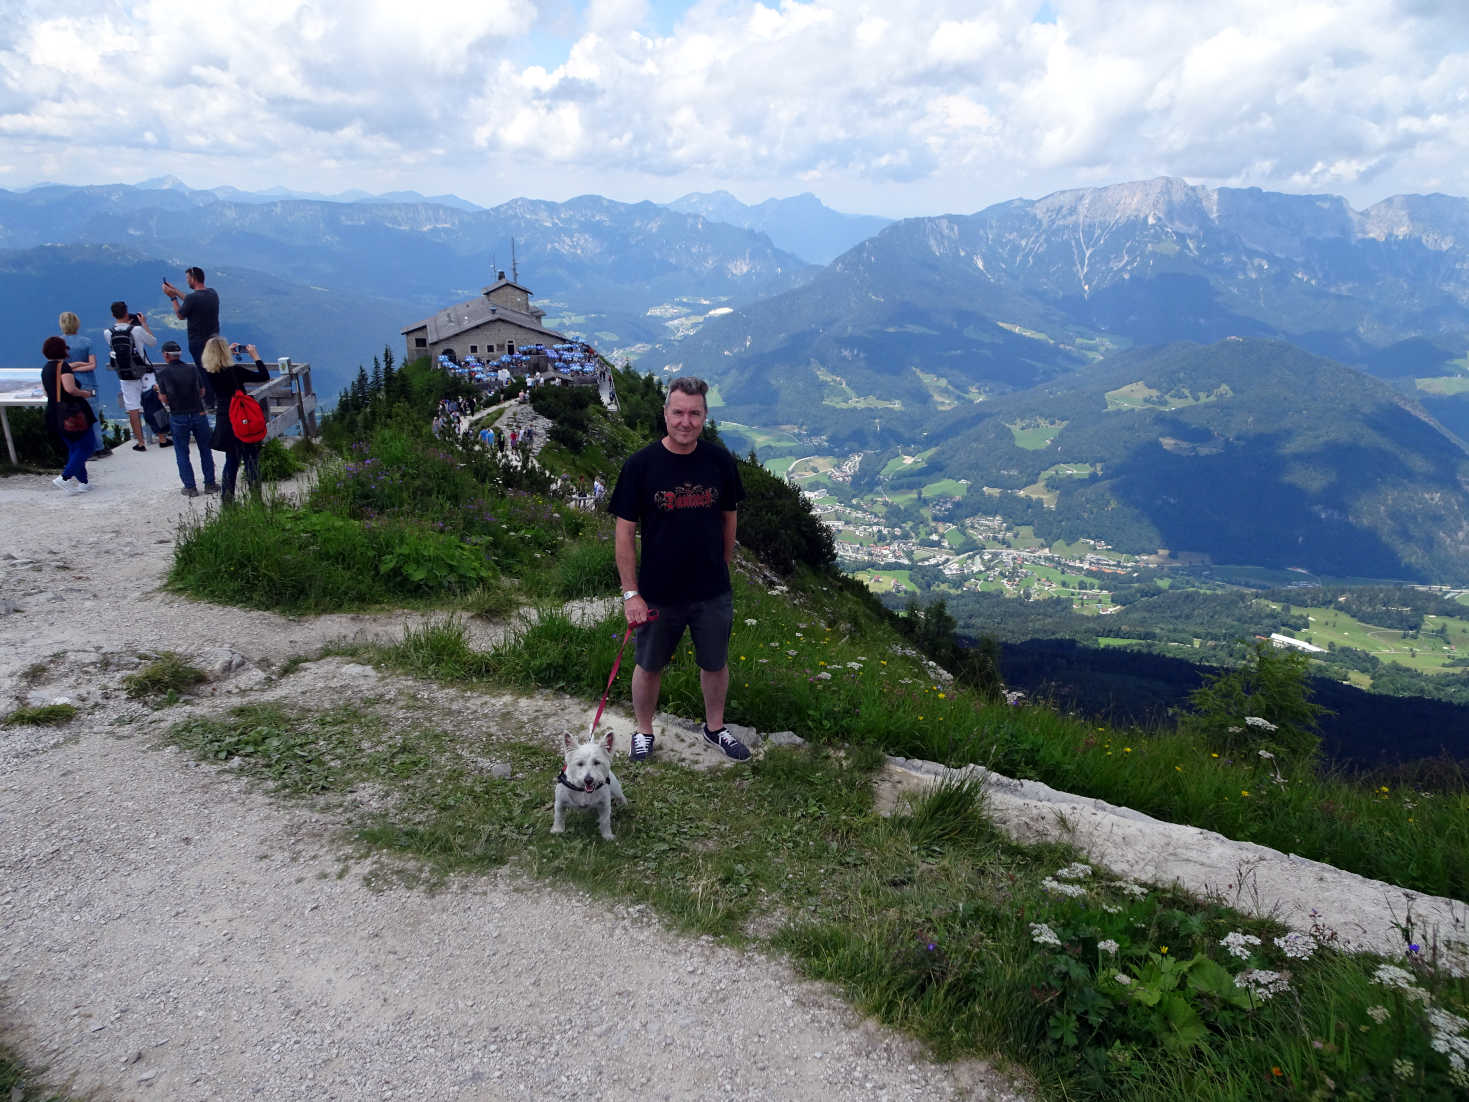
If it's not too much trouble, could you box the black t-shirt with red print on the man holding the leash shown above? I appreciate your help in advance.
[610,441,745,605]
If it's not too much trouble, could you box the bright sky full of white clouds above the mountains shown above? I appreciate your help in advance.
[0,0,1469,216]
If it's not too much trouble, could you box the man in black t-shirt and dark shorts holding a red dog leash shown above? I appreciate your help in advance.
[611,376,749,761]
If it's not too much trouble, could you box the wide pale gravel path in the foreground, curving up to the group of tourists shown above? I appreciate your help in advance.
[0,450,1018,1099]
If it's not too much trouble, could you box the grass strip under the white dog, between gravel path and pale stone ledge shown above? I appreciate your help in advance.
[160,699,1469,1102]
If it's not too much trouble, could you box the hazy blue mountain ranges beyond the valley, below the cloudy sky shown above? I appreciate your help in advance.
[0,179,1469,577]
